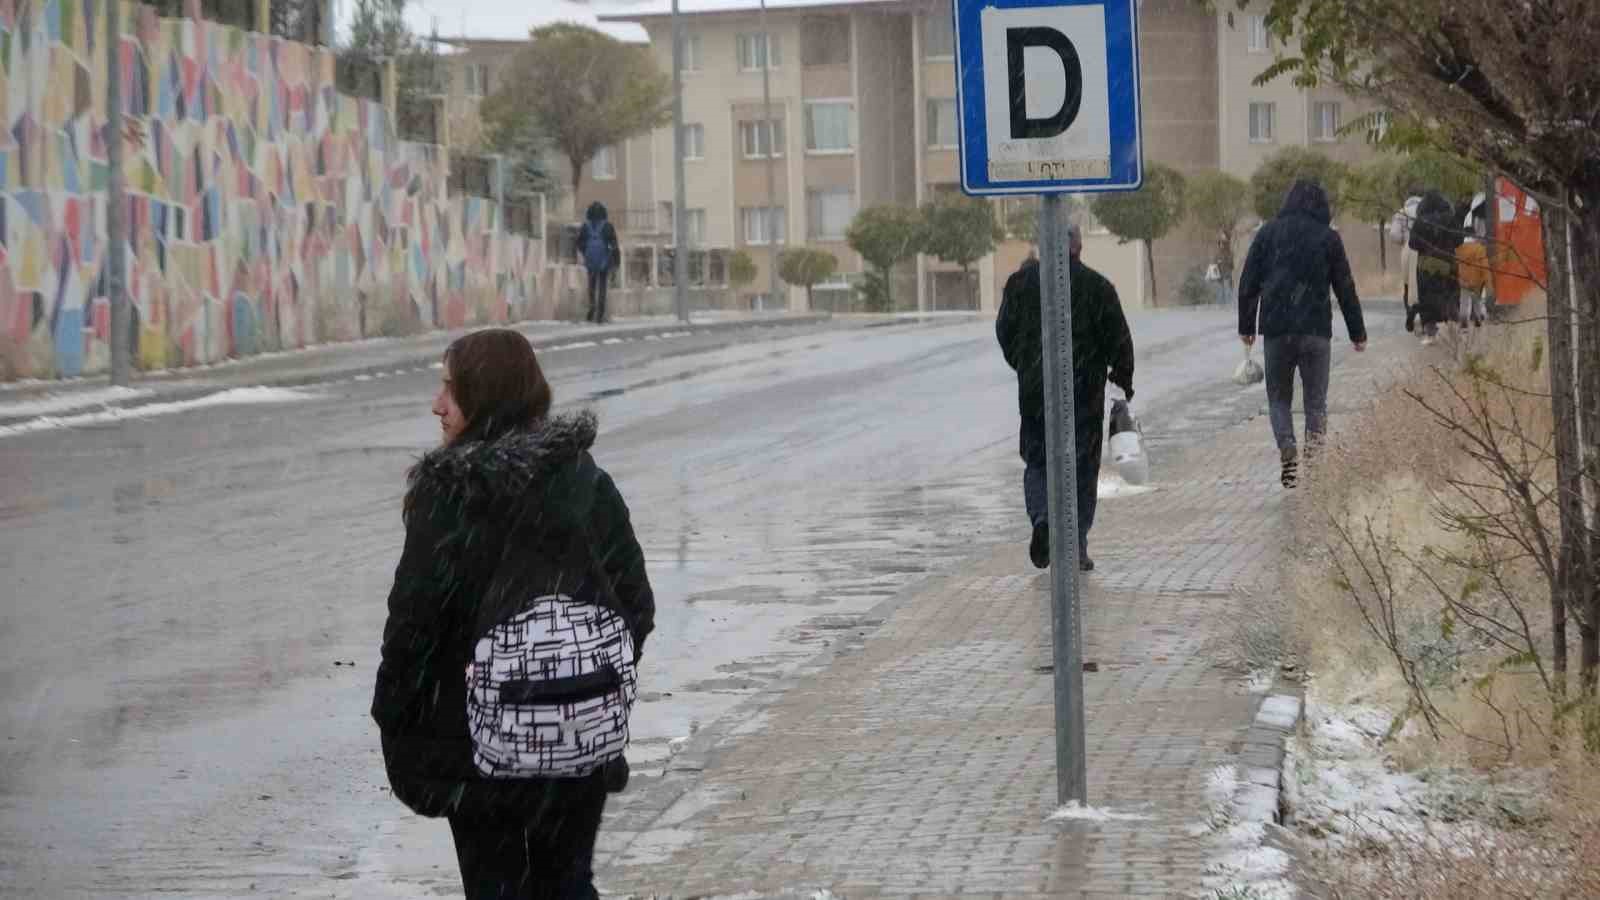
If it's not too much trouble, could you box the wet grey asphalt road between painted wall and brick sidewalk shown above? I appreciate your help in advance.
[0,305,1286,897]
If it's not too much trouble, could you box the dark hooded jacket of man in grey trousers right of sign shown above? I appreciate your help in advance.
[1238,181,1366,343]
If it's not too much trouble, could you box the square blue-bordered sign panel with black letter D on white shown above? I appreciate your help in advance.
[952,0,1144,195]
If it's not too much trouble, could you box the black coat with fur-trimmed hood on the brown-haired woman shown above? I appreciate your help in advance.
[373,412,656,818]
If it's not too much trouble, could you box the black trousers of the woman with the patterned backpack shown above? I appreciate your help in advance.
[450,773,606,900]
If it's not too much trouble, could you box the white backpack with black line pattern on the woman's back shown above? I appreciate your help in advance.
[467,554,638,778]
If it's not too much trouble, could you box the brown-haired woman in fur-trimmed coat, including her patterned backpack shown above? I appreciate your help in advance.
[373,328,654,900]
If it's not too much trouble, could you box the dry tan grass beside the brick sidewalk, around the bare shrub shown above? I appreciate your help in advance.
[1283,311,1600,900]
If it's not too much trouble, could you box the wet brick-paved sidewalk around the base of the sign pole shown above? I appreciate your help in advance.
[597,333,1408,898]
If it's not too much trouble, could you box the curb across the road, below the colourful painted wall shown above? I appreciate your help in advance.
[0,314,829,428]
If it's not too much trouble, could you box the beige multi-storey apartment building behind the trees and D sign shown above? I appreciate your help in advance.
[428,0,1376,311]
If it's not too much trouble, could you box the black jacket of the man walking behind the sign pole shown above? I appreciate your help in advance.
[995,259,1133,418]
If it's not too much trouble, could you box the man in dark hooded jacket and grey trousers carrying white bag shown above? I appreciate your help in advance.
[1238,174,1366,487]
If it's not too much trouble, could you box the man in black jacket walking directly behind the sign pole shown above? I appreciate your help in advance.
[995,226,1133,572]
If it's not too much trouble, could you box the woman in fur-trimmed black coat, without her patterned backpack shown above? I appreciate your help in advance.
[373,328,654,900]
